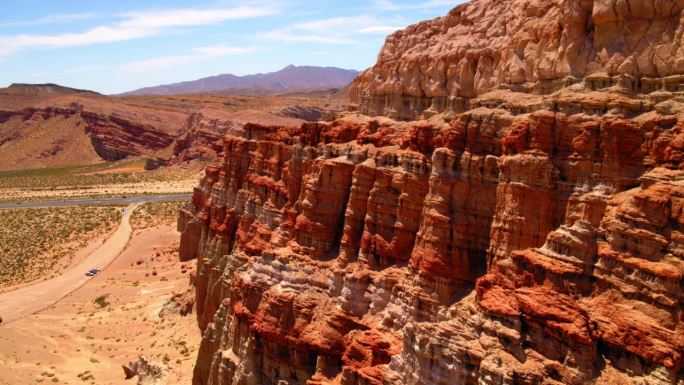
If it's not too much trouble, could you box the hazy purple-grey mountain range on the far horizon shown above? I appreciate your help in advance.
[122,65,359,95]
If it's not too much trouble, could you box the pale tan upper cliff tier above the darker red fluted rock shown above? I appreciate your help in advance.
[350,0,684,119]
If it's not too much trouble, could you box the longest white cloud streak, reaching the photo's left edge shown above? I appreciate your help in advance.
[0,6,277,57]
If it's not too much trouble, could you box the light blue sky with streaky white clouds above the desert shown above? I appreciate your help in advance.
[0,0,463,94]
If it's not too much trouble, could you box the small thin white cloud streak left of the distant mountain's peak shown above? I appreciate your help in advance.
[120,45,258,72]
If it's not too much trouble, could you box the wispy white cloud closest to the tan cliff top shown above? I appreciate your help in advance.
[261,15,401,44]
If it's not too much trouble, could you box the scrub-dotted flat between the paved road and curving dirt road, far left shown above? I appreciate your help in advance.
[0,206,121,287]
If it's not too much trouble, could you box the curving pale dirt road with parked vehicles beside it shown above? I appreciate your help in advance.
[0,202,142,323]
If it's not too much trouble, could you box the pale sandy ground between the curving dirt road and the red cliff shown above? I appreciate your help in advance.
[0,225,200,385]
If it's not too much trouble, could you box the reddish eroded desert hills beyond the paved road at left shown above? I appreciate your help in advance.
[0,84,345,170]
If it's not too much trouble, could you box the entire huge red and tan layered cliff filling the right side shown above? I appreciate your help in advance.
[179,0,684,385]
